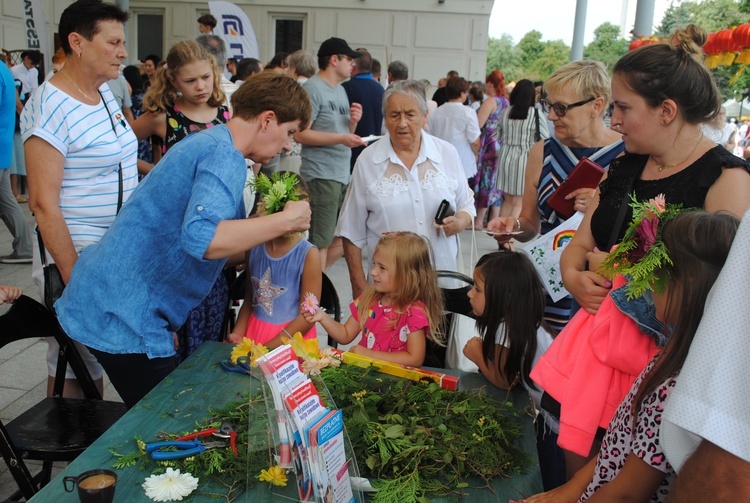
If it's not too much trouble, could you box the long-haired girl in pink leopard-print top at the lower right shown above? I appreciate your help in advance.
[523,211,739,503]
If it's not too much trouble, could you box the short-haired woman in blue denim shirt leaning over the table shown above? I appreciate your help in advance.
[55,72,310,407]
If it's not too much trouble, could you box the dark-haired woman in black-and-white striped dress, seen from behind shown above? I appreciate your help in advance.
[497,79,549,218]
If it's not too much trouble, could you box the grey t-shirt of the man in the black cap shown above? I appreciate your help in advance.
[300,75,352,185]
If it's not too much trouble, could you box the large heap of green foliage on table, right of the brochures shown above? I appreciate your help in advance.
[321,365,529,502]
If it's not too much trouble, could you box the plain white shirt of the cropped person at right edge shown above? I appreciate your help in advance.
[662,210,750,473]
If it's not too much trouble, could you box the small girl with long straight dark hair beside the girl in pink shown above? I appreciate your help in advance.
[463,250,564,488]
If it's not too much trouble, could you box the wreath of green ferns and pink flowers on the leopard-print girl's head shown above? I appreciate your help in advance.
[602,194,684,300]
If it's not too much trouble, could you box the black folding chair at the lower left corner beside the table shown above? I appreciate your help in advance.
[0,296,127,501]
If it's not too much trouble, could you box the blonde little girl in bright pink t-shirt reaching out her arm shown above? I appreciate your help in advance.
[303,232,443,367]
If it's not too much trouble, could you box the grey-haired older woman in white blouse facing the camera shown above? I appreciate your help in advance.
[336,80,476,298]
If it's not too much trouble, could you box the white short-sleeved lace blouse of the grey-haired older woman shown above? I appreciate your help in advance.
[336,132,476,271]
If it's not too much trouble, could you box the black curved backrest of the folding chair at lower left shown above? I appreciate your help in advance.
[0,295,102,400]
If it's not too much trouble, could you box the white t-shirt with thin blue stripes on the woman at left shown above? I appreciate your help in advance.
[21,82,138,245]
